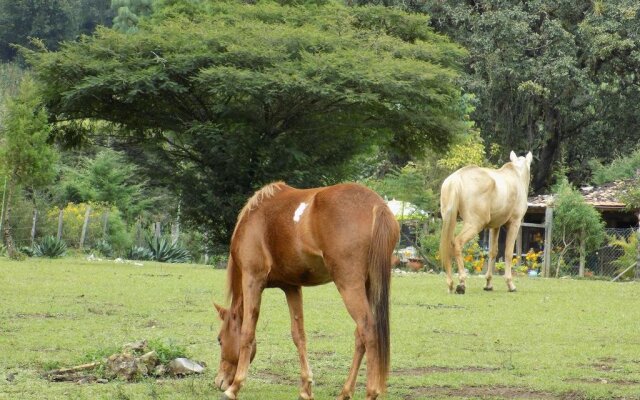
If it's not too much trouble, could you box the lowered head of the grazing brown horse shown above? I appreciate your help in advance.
[215,304,256,390]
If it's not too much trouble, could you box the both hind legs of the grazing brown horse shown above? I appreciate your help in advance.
[336,282,384,400]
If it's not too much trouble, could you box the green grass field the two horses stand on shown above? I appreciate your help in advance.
[0,258,640,400]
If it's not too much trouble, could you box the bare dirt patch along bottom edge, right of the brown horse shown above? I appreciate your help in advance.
[405,386,586,400]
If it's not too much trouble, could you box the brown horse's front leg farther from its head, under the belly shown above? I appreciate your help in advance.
[283,286,313,400]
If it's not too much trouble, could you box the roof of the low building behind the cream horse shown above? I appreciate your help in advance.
[528,180,631,211]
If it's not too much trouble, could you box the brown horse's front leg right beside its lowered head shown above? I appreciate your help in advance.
[222,275,264,400]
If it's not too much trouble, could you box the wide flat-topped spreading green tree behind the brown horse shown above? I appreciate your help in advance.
[25,1,465,248]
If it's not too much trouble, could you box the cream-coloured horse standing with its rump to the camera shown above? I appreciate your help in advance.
[440,151,533,294]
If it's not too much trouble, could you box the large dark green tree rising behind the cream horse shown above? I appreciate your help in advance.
[364,0,640,191]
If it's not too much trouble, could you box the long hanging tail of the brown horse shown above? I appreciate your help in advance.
[367,206,400,388]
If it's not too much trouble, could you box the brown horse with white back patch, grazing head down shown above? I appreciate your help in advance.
[216,182,399,400]
